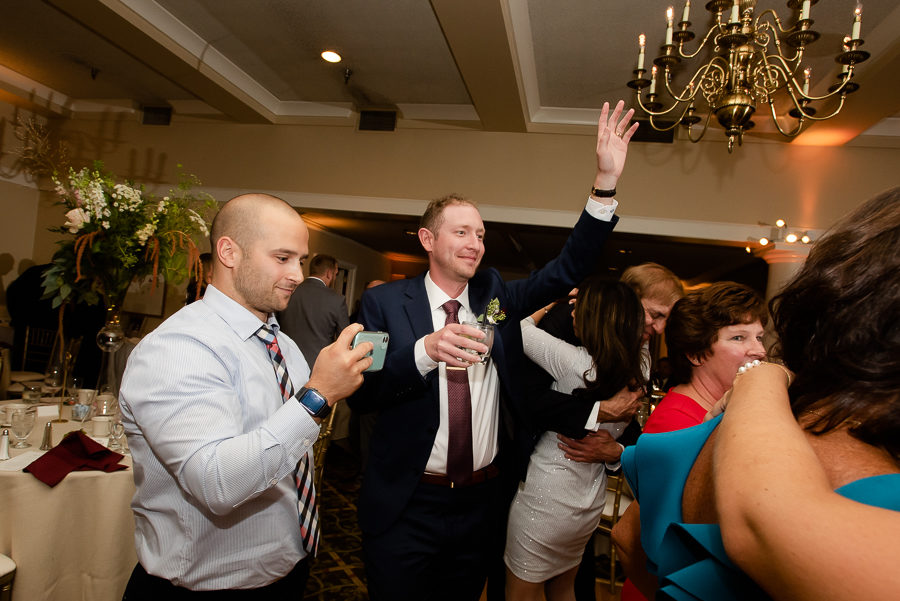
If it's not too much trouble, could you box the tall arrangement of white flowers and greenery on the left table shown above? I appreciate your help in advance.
[43,162,215,307]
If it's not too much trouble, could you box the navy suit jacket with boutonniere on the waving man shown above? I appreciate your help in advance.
[348,212,618,535]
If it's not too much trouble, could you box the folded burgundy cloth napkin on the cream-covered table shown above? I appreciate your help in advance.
[22,430,128,486]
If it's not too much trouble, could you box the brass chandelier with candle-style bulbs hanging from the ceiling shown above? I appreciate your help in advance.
[628,0,869,152]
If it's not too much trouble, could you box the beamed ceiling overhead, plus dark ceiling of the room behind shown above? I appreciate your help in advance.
[0,0,900,288]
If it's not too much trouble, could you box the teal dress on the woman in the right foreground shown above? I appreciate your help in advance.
[622,416,900,601]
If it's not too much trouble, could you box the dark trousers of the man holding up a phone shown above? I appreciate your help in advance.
[122,558,309,601]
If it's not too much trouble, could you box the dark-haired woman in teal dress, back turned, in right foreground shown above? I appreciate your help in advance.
[614,189,900,601]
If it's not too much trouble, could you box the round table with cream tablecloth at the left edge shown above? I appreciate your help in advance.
[0,402,137,601]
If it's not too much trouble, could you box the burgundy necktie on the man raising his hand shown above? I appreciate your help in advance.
[441,300,472,482]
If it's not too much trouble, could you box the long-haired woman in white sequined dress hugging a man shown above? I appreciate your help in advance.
[504,278,644,601]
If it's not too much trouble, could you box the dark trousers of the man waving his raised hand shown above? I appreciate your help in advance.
[363,478,505,601]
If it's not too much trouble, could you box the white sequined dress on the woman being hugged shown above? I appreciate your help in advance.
[504,318,627,582]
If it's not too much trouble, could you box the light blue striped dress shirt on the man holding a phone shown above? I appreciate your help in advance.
[120,286,319,590]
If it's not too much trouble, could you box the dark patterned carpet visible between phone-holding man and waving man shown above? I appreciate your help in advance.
[303,444,369,601]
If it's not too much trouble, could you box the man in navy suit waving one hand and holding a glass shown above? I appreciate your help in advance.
[348,101,637,601]
